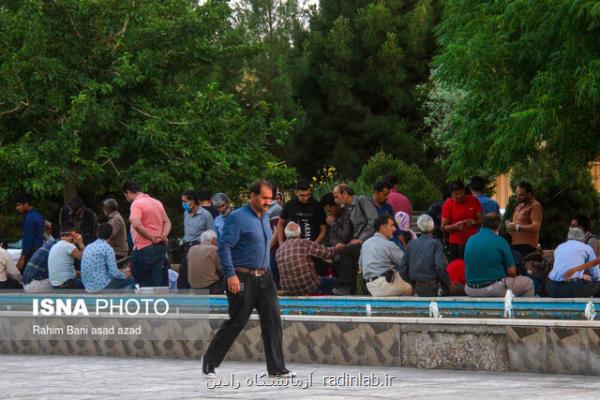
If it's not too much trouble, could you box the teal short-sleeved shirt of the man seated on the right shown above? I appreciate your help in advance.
[465,228,515,284]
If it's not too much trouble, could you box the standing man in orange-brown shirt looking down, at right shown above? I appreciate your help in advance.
[506,181,544,257]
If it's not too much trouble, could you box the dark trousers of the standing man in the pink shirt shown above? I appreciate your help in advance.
[131,244,167,286]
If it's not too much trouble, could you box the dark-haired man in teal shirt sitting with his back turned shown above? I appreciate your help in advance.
[465,213,534,297]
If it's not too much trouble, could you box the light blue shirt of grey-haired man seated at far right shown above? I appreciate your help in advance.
[548,240,599,281]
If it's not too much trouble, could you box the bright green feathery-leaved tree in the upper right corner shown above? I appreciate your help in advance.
[432,0,600,176]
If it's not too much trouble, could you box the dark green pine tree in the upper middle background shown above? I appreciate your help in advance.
[291,0,440,177]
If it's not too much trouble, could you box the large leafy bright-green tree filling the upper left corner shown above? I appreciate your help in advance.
[0,0,293,203]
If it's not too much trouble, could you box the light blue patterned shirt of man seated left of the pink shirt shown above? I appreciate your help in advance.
[81,239,125,292]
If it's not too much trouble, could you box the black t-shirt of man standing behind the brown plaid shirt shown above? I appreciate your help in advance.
[281,198,326,240]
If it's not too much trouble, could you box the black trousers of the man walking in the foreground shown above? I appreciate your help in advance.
[204,271,285,374]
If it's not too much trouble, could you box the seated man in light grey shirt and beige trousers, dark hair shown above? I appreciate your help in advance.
[358,214,412,296]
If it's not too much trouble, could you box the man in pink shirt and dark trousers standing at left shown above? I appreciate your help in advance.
[123,181,171,286]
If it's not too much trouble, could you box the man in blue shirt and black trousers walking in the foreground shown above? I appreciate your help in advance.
[202,180,290,378]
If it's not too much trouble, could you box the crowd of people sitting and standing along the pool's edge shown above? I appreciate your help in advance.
[0,176,600,297]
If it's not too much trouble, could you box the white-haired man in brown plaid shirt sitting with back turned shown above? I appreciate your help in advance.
[276,222,336,296]
